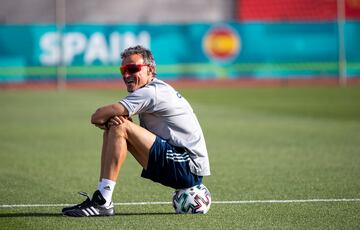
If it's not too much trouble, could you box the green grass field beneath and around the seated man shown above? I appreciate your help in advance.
[0,87,360,229]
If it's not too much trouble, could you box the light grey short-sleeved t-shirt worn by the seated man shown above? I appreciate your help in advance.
[120,78,210,176]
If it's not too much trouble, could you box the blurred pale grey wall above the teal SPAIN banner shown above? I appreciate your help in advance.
[0,0,235,23]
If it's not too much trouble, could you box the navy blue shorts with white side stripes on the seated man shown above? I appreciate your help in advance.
[141,137,202,189]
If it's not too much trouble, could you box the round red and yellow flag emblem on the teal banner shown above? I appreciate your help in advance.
[203,26,241,61]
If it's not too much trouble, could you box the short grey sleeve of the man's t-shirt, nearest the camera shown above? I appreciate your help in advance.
[119,87,155,116]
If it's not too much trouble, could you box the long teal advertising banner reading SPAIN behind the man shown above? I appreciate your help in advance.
[0,21,360,82]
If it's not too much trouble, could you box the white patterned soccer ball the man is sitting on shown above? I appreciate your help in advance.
[172,184,211,214]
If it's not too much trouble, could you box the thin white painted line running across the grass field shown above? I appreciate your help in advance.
[0,198,360,208]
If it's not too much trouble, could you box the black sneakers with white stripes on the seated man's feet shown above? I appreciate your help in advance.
[62,190,115,217]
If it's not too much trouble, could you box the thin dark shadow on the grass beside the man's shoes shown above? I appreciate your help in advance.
[0,212,176,218]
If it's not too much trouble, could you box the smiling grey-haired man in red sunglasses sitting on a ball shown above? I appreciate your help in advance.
[62,46,210,217]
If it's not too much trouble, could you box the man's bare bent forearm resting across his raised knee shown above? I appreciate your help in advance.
[91,103,129,126]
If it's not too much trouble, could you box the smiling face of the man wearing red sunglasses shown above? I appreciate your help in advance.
[121,54,153,92]
